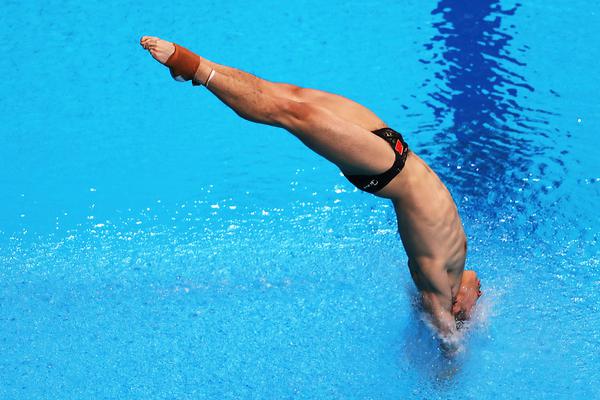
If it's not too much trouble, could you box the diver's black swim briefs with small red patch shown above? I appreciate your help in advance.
[344,128,408,193]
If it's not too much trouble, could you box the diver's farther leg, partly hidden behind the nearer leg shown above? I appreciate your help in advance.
[142,36,386,131]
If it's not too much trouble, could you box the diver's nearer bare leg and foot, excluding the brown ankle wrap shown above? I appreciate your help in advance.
[142,37,395,175]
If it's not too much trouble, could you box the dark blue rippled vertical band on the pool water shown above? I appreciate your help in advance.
[416,0,567,209]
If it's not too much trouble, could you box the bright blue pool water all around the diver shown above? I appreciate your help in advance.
[0,0,600,399]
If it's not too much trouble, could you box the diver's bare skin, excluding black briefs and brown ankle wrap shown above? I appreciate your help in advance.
[140,36,481,343]
